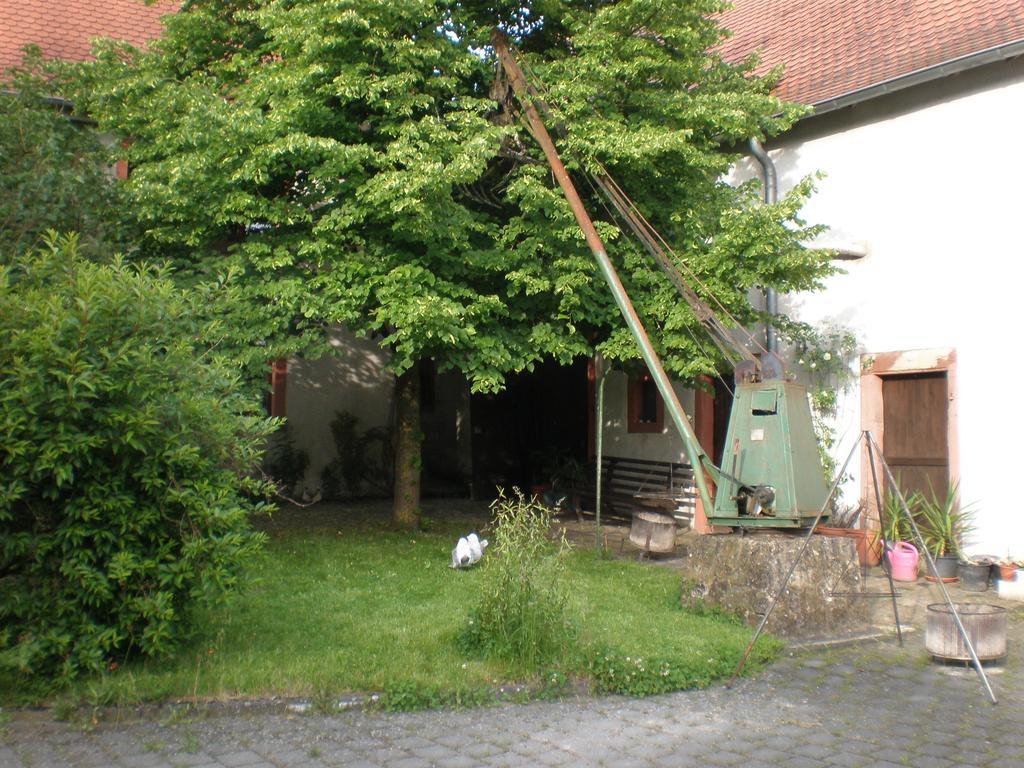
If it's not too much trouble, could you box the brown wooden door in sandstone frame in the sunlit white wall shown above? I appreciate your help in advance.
[882,372,949,499]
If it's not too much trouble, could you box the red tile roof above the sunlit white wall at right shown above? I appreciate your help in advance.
[721,0,1024,104]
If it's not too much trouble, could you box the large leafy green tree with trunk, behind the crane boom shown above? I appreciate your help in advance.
[79,0,825,523]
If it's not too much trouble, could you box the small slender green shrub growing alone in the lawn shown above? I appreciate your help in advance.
[460,490,577,672]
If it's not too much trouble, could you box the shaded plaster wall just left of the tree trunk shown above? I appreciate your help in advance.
[285,328,394,495]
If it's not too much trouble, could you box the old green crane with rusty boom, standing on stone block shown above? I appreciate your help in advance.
[492,31,827,528]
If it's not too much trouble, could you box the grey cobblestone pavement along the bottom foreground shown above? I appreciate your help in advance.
[0,613,1024,768]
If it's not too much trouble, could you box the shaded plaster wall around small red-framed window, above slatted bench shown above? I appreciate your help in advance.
[602,371,693,464]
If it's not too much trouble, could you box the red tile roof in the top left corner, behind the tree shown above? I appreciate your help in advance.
[0,0,181,70]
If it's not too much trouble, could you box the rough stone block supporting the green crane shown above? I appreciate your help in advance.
[680,531,869,640]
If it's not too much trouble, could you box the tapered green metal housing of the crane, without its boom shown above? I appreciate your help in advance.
[709,380,828,527]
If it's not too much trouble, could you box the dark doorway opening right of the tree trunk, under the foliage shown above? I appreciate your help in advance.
[470,357,588,499]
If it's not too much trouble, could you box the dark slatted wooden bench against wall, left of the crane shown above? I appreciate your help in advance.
[571,456,696,526]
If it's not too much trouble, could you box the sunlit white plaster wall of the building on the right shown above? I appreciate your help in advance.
[733,66,1024,556]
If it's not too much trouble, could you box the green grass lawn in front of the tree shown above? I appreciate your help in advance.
[3,505,778,703]
